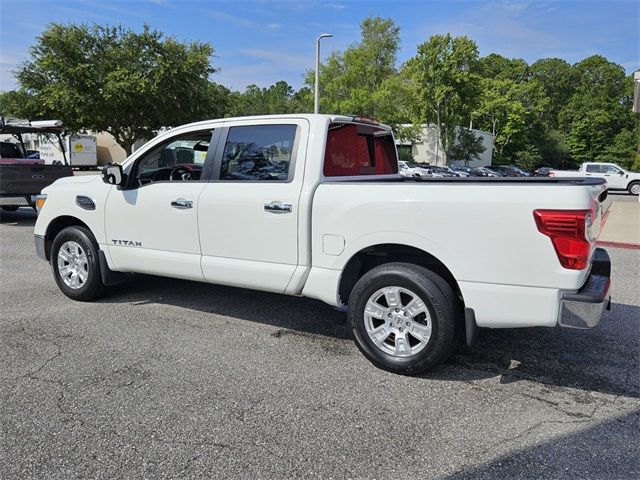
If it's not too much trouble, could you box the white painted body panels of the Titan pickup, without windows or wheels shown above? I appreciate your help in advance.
[35,115,604,328]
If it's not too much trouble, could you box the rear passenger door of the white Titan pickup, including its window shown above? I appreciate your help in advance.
[198,119,309,292]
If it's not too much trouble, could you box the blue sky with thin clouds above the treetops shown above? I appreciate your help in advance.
[0,0,640,90]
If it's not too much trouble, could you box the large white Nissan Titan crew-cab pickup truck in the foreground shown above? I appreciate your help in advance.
[35,115,610,374]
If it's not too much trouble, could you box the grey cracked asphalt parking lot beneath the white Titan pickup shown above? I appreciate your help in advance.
[0,203,640,479]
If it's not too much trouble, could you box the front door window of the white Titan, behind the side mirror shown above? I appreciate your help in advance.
[136,130,212,185]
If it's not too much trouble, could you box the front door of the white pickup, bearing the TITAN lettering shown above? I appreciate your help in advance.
[105,129,213,280]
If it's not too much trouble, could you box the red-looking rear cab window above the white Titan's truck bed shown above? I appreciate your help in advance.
[323,123,398,177]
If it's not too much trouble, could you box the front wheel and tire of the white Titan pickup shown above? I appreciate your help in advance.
[51,227,105,302]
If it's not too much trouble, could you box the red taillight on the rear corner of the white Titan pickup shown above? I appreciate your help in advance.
[533,210,592,270]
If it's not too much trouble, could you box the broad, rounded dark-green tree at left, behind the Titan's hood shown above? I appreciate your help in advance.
[10,24,217,153]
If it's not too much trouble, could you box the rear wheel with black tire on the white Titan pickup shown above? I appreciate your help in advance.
[348,263,462,375]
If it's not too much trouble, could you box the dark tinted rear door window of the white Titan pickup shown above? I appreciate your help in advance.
[220,125,298,181]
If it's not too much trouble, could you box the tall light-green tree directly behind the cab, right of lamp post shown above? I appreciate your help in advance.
[306,17,400,121]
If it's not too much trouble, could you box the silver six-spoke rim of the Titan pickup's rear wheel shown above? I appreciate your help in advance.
[364,287,432,357]
